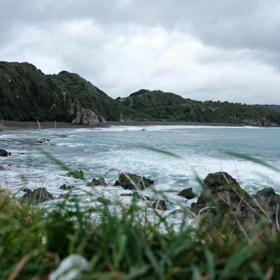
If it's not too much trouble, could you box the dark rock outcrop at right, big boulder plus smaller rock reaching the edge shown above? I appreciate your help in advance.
[192,172,280,228]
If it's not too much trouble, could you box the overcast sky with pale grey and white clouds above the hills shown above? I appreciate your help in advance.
[0,0,280,104]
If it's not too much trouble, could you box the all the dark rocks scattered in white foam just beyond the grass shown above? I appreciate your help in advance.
[12,161,280,230]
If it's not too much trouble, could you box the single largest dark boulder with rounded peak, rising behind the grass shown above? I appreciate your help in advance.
[192,172,263,224]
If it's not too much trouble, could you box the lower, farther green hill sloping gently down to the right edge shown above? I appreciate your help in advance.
[118,90,280,126]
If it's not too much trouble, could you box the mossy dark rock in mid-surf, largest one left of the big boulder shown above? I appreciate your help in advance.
[114,172,154,190]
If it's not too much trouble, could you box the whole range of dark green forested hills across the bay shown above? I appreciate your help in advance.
[0,62,280,126]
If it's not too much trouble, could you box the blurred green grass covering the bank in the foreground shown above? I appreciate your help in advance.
[0,186,280,279]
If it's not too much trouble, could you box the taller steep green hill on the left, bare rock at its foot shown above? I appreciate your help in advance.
[0,62,120,124]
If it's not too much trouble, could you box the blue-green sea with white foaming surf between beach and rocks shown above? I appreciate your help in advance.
[0,126,280,212]
